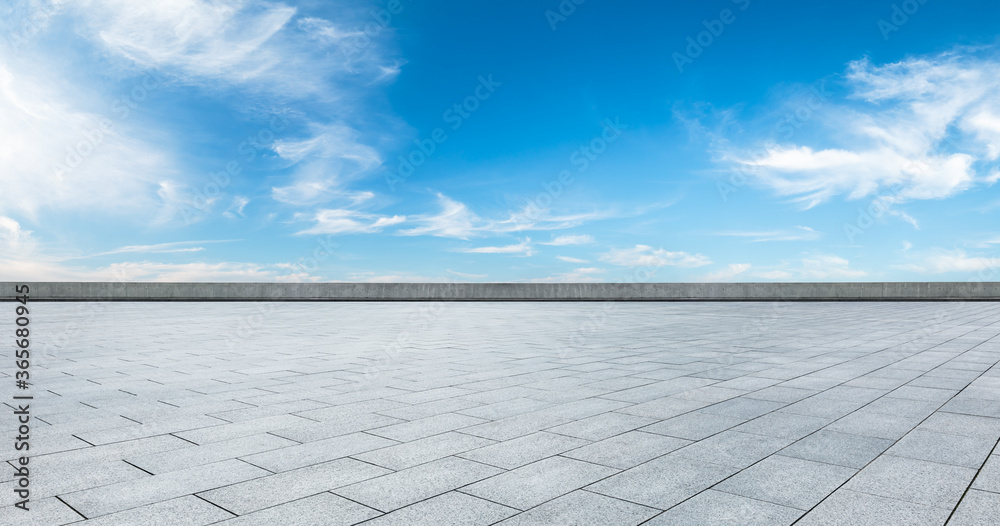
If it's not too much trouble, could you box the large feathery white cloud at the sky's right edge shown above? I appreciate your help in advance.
[723,51,1000,208]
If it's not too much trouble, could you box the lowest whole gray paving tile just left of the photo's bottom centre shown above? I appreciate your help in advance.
[333,457,503,512]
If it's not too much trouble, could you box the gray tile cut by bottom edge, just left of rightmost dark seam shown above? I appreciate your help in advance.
[796,489,949,526]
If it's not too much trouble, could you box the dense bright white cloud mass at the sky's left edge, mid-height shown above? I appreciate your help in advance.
[0,59,174,218]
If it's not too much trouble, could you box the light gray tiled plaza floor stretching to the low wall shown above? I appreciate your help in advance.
[0,302,1000,526]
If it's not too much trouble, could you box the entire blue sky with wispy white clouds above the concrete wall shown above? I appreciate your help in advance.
[0,0,1000,282]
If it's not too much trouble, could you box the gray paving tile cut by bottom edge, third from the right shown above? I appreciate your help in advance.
[646,490,802,526]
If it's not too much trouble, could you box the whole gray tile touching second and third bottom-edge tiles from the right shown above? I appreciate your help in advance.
[713,455,858,510]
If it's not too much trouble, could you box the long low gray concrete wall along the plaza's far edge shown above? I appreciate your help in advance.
[0,282,1000,301]
